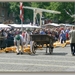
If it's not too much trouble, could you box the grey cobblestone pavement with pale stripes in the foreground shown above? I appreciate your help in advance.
[0,46,75,72]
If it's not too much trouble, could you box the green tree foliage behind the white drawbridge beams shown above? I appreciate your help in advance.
[9,2,75,22]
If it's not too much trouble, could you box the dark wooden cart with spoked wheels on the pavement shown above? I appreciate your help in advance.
[30,34,55,54]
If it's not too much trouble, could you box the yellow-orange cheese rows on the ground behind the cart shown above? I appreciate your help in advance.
[0,40,70,53]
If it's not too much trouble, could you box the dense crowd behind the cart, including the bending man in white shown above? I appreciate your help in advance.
[0,27,72,54]
